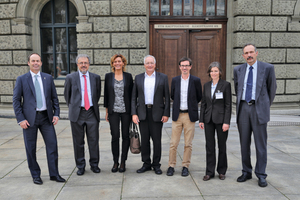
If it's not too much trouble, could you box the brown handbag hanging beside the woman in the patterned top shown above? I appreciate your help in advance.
[129,122,141,154]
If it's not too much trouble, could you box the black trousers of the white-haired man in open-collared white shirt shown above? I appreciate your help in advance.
[140,108,163,167]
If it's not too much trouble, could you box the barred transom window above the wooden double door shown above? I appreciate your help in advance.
[150,0,226,17]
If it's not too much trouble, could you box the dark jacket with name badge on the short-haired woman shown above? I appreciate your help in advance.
[199,79,232,124]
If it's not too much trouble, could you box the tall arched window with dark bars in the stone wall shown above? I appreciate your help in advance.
[40,0,78,78]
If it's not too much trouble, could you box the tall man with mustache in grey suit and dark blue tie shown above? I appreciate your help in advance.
[234,44,277,187]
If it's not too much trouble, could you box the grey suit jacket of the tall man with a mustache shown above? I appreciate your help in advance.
[234,61,277,124]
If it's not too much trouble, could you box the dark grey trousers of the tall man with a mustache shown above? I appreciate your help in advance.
[238,101,268,178]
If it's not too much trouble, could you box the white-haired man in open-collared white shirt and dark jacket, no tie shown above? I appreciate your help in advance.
[131,55,170,174]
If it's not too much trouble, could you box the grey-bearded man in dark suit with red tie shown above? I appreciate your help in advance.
[64,54,101,176]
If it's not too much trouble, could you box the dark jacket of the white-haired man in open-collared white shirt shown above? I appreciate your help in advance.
[131,72,170,122]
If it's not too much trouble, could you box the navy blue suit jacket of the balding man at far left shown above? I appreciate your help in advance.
[13,72,60,125]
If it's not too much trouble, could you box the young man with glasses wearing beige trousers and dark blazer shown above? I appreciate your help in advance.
[167,57,202,176]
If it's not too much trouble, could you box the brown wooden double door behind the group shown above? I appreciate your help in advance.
[150,23,226,86]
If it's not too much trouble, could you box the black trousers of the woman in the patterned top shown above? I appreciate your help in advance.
[108,112,131,163]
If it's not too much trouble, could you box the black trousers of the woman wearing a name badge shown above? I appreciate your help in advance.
[204,121,228,176]
